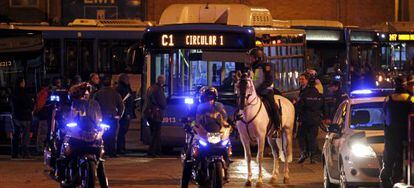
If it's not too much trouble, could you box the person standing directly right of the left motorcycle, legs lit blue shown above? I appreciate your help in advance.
[94,77,124,157]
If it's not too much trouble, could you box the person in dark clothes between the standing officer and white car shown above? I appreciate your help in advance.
[325,80,348,124]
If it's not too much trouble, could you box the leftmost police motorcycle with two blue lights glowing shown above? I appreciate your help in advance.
[57,83,109,188]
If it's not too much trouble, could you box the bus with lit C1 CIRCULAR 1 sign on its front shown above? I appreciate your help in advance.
[137,4,306,147]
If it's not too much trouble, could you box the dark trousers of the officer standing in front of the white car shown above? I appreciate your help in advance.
[380,136,404,188]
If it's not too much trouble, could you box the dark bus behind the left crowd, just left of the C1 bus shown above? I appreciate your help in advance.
[16,19,153,91]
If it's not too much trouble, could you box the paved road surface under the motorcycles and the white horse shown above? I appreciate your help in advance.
[0,153,323,188]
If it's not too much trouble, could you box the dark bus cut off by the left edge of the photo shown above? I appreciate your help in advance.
[0,24,43,147]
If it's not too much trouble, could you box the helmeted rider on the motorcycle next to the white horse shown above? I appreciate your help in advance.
[181,86,231,188]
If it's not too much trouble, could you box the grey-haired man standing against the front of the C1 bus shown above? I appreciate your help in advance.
[144,75,167,157]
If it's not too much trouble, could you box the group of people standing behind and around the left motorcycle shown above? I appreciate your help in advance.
[11,73,135,158]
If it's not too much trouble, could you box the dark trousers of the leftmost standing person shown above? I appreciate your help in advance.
[12,119,31,157]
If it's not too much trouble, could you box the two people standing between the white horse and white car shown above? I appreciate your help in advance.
[294,69,348,163]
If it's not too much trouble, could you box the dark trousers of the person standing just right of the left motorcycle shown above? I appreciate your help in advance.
[103,117,118,156]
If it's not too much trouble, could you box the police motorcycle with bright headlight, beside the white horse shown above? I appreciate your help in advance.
[179,87,232,188]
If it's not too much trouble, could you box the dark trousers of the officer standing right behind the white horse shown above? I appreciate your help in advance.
[298,123,319,155]
